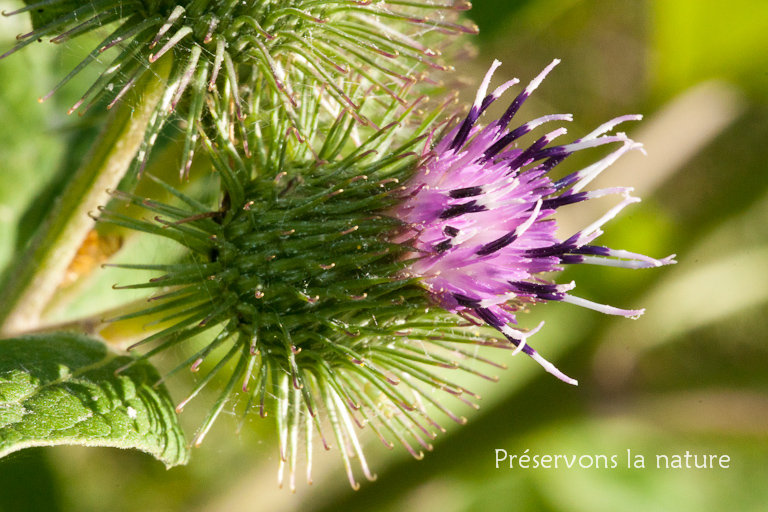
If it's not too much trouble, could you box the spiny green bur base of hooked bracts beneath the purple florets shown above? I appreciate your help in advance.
[101,83,514,487]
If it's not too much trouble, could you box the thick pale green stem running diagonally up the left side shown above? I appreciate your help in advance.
[0,55,171,335]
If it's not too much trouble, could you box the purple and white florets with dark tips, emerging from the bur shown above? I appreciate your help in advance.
[393,60,674,384]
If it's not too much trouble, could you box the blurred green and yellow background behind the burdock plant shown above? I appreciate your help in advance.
[0,0,768,512]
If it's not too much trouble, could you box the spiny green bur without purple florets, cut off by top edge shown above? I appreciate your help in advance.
[0,0,476,174]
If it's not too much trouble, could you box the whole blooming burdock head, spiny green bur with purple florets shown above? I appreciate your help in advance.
[99,56,672,488]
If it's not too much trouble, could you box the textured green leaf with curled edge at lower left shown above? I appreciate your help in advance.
[0,332,189,468]
